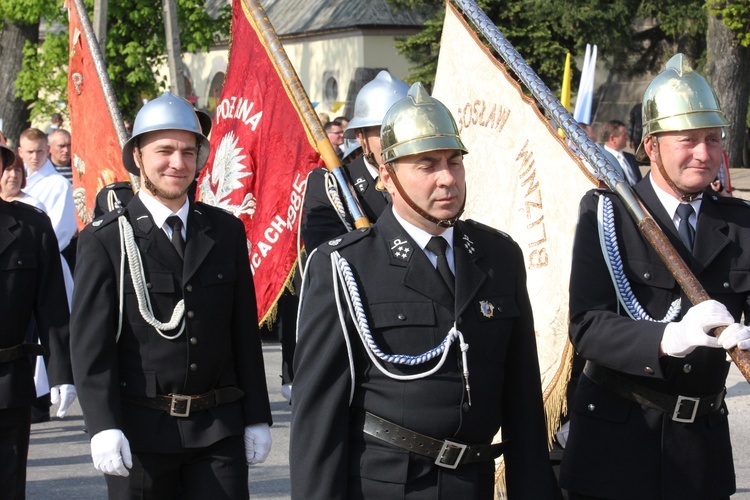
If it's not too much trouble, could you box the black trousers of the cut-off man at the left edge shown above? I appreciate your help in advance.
[0,406,31,500]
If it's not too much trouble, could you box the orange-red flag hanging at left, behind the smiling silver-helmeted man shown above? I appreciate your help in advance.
[66,0,129,229]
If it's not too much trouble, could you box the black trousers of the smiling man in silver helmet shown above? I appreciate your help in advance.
[104,436,248,500]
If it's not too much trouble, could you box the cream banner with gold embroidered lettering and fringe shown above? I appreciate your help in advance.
[433,2,595,454]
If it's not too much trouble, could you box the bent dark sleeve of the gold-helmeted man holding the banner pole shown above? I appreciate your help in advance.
[570,193,665,377]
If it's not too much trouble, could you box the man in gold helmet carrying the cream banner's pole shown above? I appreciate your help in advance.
[560,54,750,499]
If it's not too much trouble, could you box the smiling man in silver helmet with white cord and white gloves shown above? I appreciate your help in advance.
[71,92,271,498]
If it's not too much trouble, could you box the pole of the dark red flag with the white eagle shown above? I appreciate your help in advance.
[244,0,370,228]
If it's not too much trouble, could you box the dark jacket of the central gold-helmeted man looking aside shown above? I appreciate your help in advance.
[289,207,554,499]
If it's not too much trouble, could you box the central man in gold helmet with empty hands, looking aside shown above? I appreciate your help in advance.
[289,83,556,499]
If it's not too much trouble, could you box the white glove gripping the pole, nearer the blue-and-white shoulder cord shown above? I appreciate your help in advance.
[661,300,734,358]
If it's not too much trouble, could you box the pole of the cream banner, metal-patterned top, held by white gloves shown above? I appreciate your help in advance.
[453,0,750,382]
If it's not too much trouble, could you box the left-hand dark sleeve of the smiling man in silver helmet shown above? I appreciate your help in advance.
[70,231,122,436]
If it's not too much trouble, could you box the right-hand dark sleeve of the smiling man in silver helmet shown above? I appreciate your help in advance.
[232,220,272,425]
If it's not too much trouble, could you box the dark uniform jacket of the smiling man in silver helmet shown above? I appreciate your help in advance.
[71,196,271,453]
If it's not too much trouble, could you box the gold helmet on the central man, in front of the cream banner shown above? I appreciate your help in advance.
[380,82,469,163]
